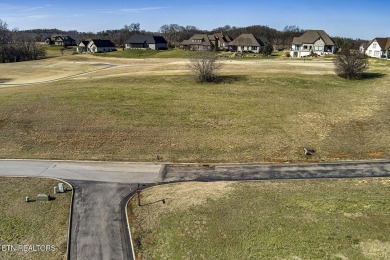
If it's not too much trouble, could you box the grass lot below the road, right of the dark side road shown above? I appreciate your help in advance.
[128,179,390,260]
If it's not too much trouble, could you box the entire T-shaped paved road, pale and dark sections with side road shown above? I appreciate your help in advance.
[0,160,390,260]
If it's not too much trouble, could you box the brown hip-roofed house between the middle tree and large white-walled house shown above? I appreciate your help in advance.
[229,34,265,53]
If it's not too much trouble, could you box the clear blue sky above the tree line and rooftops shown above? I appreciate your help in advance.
[0,0,390,40]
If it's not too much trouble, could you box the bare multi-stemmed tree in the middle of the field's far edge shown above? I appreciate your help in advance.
[188,51,222,82]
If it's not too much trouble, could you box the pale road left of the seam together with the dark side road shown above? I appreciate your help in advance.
[0,160,161,260]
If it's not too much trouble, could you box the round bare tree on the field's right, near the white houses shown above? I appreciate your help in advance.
[334,48,368,79]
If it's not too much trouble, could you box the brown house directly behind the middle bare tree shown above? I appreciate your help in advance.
[180,34,218,51]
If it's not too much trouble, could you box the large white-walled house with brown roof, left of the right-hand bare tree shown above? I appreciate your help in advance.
[290,30,337,58]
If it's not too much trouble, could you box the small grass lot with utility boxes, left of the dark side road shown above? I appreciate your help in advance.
[0,177,72,260]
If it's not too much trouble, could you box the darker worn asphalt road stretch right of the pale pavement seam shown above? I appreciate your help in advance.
[158,161,390,183]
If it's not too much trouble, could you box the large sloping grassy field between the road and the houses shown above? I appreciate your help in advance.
[0,55,390,162]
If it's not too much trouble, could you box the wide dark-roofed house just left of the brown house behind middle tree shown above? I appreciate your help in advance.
[125,35,168,50]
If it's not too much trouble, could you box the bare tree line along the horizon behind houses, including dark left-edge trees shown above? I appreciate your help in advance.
[0,17,365,63]
